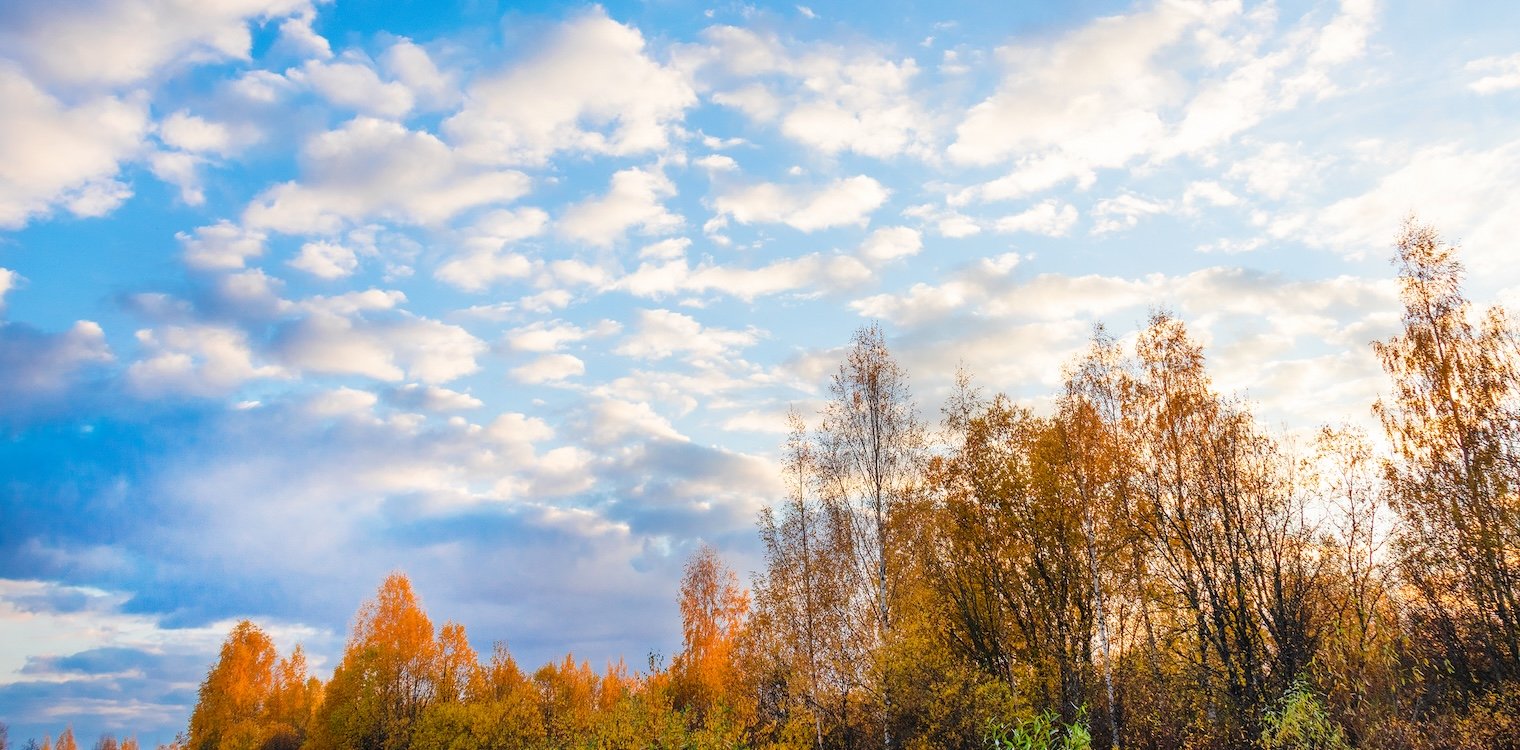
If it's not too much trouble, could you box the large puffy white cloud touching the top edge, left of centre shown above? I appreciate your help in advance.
[444,8,696,164]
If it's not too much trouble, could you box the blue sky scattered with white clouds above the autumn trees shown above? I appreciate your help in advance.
[0,0,1520,744]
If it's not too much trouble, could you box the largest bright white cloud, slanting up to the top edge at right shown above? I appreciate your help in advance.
[945,0,1376,204]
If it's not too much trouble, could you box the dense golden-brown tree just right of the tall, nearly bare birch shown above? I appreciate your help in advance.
[932,374,1094,730]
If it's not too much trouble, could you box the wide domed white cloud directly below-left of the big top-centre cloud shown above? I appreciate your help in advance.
[243,117,529,234]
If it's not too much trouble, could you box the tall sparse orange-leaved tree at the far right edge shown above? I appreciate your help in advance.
[1373,219,1520,689]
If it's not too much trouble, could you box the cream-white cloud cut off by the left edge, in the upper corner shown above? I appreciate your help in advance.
[0,67,149,228]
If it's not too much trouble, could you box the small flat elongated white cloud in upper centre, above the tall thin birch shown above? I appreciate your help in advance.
[713,175,889,231]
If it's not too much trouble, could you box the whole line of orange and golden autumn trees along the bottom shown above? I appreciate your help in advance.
[35,221,1520,750]
